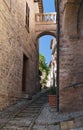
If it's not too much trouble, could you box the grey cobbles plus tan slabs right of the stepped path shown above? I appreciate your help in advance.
[33,103,83,130]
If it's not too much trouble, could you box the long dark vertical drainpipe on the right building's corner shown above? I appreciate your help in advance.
[56,0,60,112]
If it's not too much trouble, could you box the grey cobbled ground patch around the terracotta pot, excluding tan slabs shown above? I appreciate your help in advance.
[36,103,83,125]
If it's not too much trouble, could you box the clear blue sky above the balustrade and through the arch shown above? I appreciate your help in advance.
[39,0,55,64]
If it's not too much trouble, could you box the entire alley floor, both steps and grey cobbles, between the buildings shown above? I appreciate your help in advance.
[0,90,83,130]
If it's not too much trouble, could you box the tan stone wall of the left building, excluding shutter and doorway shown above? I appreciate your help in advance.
[0,0,39,110]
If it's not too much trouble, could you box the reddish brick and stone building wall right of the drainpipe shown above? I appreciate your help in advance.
[56,0,83,112]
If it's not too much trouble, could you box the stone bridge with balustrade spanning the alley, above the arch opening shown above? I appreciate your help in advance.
[35,13,56,36]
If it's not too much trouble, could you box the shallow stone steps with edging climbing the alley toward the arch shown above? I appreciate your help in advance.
[1,93,48,130]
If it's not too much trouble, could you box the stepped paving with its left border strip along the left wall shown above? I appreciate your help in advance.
[0,91,48,130]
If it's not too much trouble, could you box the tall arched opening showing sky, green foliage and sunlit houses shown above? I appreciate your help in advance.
[38,35,57,89]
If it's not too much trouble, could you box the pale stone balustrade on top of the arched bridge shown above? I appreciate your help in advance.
[35,13,56,22]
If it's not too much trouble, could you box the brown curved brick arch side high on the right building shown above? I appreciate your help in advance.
[63,0,81,37]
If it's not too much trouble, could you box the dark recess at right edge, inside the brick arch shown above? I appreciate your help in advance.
[78,1,83,37]
